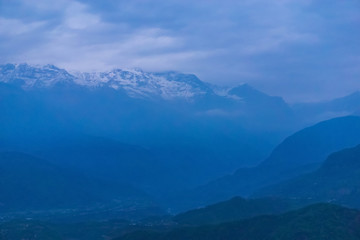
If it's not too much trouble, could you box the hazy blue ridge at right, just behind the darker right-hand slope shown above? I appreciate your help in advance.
[174,116,360,212]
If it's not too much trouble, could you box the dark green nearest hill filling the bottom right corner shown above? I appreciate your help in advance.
[118,204,360,240]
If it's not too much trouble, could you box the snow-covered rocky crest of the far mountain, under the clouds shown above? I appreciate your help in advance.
[0,64,214,100]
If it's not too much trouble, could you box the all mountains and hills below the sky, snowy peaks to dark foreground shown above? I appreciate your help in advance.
[0,64,360,239]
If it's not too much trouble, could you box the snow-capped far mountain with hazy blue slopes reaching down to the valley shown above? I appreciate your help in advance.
[0,64,293,202]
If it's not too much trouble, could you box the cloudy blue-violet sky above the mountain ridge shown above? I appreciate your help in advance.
[0,0,360,102]
